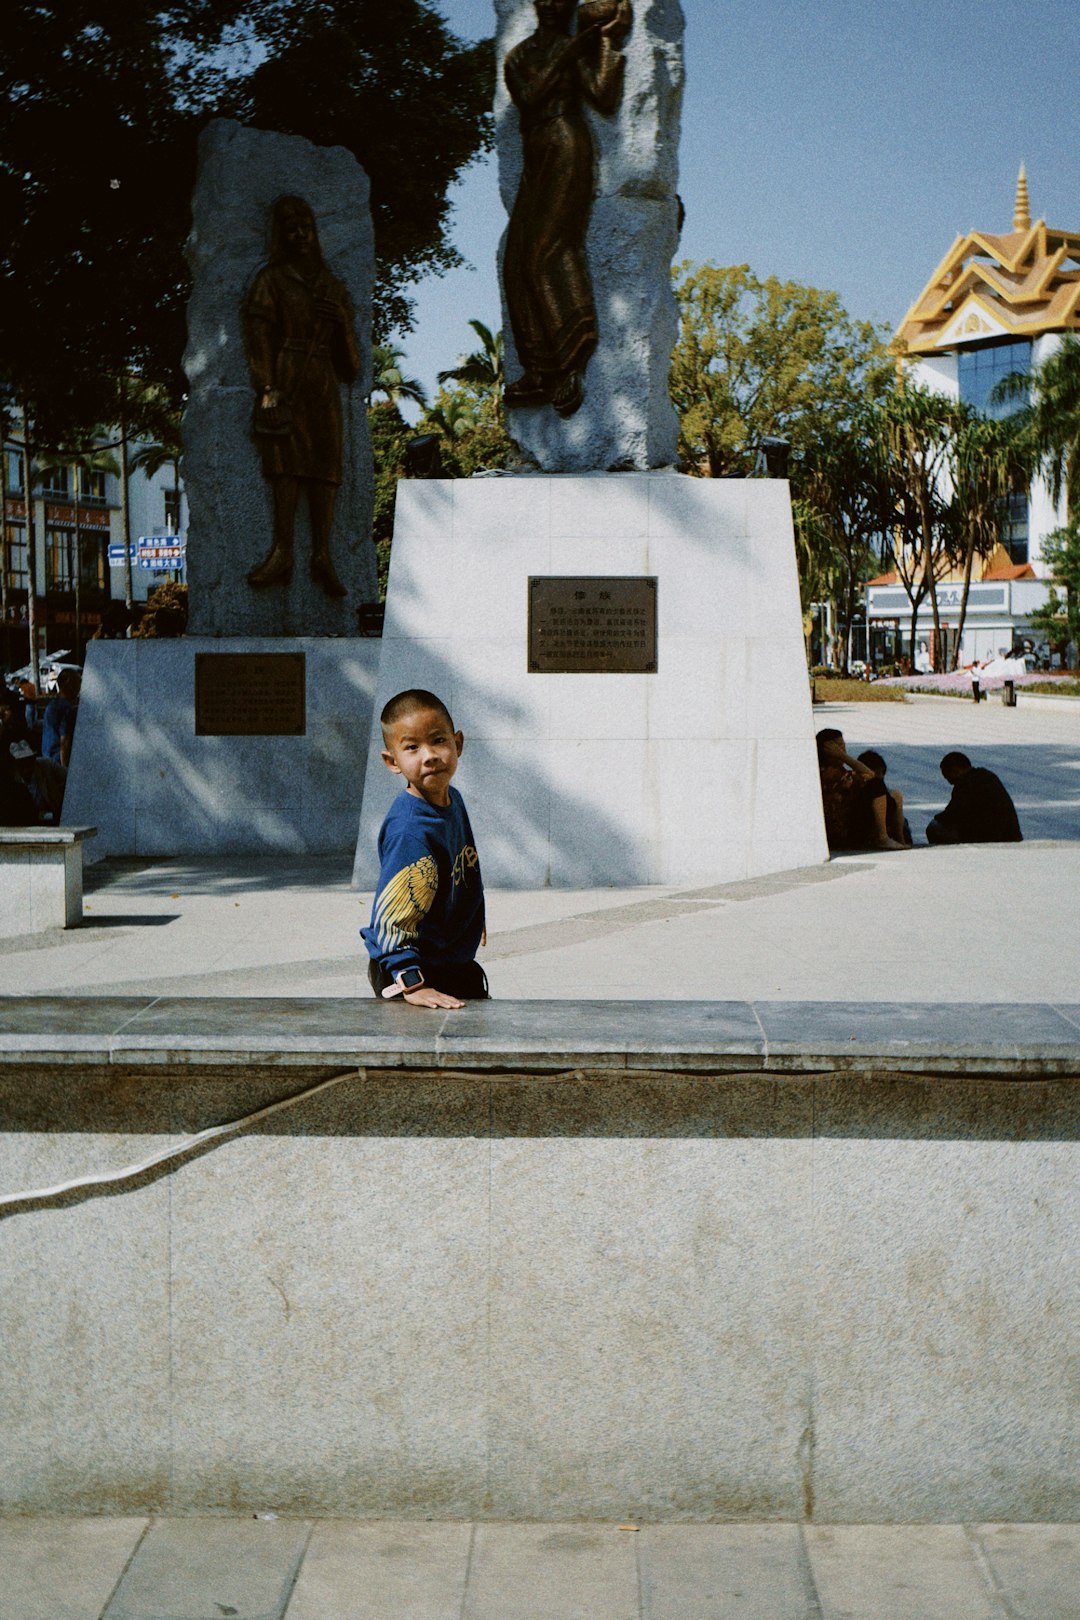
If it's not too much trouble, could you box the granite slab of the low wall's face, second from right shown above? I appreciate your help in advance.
[489,1076,813,1520]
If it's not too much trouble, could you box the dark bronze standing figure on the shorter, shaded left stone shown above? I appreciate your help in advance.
[243,198,359,596]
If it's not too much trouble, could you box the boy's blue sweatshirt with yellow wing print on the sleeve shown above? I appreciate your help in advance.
[359,786,484,974]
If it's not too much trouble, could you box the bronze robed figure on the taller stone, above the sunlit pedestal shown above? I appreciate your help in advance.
[502,0,631,416]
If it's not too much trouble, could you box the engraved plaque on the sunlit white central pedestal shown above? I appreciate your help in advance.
[529,575,656,676]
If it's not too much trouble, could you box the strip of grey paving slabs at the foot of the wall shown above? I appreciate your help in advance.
[0,1518,1080,1620]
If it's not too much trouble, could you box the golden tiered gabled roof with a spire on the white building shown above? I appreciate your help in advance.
[895,165,1080,355]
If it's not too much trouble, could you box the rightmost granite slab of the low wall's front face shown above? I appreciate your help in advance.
[811,1079,1080,1516]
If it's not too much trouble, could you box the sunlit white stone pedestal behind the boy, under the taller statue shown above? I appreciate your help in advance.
[354,473,827,888]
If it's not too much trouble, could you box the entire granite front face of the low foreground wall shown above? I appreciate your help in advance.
[0,1049,1080,1516]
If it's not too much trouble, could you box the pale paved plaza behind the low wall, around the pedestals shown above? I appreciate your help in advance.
[0,693,1080,1003]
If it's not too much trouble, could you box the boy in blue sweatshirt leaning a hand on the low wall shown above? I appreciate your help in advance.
[361,689,487,1008]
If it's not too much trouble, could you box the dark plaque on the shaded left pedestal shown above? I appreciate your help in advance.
[194,653,306,737]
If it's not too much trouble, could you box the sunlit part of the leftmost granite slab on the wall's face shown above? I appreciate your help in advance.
[0,1134,170,1515]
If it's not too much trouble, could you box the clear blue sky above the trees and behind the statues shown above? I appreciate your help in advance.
[403,0,1080,392]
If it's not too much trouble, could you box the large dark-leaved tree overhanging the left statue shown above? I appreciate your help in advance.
[0,0,494,446]
